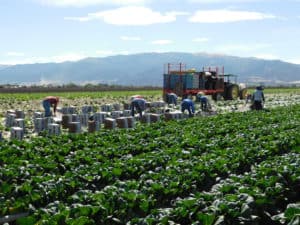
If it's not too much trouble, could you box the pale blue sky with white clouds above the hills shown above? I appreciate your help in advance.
[0,0,300,64]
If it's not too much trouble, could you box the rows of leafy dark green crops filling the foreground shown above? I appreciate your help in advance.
[0,89,300,225]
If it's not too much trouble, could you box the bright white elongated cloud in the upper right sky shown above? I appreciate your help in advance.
[189,9,276,23]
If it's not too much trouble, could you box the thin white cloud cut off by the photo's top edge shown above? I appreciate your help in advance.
[35,0,148,7]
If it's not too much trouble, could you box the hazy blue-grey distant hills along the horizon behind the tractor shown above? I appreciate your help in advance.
[0,53,300,86]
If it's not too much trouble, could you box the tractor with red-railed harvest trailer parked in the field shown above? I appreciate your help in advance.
[163,63,247,100]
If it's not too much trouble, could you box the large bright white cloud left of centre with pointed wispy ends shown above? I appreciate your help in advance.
[65,6,187,26]
